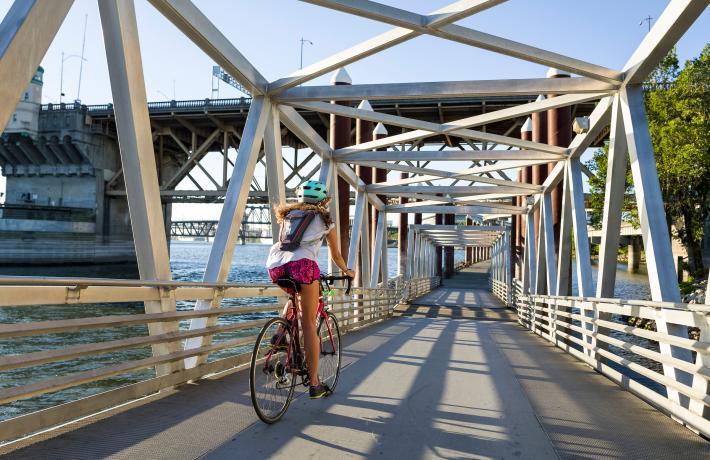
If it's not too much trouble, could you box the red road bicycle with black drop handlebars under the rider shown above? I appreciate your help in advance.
[249,275,352,423]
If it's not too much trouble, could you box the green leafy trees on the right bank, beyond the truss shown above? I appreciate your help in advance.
[587,43,710,272]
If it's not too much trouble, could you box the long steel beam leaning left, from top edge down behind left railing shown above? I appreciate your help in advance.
[101,0,181,375]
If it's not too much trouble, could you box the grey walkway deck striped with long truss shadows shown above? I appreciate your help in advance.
[2,265,710,459]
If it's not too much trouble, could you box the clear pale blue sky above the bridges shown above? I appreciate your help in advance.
[0,0,710,219]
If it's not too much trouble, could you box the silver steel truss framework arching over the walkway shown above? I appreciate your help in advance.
[0,0,710,438]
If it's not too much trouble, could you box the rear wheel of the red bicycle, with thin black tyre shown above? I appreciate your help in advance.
[249,318,296,423]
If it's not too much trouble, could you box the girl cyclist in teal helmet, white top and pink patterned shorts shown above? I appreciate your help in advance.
[266,181,355,399]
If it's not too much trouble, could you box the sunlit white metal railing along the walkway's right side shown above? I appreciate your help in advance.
[517,295,710,436]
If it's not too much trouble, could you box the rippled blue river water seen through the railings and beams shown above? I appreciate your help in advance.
[0,241,658,420]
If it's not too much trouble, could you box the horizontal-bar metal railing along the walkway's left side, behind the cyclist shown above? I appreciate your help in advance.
[0,277,418,445]
